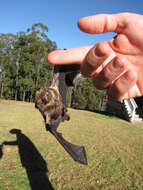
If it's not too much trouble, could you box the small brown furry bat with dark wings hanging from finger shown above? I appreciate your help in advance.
[35,64,87,165]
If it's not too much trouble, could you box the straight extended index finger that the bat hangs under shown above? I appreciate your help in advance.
[47,46,92,65]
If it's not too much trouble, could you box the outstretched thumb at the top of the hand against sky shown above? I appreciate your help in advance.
[78,13,128,34]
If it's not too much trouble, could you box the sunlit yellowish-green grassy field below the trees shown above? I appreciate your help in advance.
[0,101,143,190]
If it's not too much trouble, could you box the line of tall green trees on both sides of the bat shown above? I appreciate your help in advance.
[0,23,105,110]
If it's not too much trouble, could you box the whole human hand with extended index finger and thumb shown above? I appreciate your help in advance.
[48,13,143,100]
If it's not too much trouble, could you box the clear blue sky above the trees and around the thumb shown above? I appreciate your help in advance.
[0,0,143,49]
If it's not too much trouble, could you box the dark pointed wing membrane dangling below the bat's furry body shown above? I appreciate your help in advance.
[50,130,87,165]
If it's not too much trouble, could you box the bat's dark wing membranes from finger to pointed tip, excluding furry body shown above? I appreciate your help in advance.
[35,65,87,164]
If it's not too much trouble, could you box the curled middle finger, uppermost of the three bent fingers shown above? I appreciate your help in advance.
[81,42,115,77]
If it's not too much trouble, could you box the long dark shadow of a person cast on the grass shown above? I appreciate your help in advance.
[3,129,54,190]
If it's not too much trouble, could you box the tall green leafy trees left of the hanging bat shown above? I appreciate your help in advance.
[0,23,56,101]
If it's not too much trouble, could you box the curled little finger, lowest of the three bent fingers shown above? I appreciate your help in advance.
[108,70,137,100]
